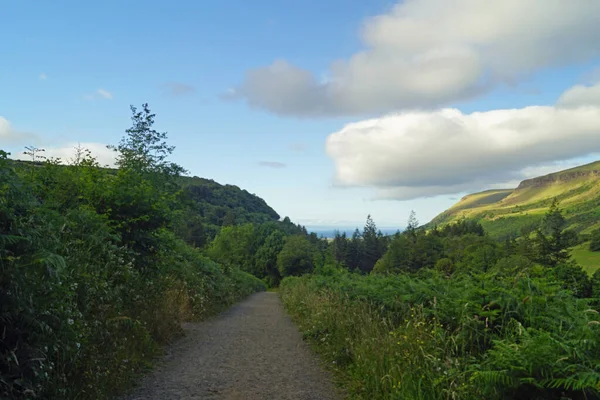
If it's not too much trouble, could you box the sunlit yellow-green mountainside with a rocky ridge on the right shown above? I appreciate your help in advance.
[428,161,600,239]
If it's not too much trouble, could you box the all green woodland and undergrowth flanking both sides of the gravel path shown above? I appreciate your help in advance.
[0,105,600,399]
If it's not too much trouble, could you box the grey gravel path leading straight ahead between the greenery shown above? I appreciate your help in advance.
[125,292,338,400]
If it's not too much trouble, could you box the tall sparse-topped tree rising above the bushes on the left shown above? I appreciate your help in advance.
[103,104,185,269]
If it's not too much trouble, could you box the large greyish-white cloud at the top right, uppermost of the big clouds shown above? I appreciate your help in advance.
[227,0,600,116]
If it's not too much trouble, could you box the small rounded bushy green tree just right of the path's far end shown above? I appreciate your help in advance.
[277,235,315,277]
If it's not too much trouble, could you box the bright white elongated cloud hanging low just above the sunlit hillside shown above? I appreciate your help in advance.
[326,84,600,199]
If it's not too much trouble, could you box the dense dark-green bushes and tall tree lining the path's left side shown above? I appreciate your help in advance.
[0,105,265,399]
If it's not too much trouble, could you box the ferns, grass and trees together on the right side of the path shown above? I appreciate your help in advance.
[280,202,600,399]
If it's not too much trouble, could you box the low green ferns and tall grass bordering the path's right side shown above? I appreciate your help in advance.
[280,273,600,399]
